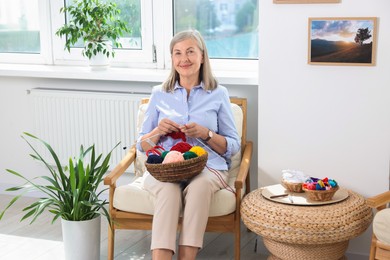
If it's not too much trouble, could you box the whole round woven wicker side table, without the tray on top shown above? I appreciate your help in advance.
[241,188,372,260]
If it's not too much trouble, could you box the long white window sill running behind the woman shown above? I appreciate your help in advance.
[0,64,258,86]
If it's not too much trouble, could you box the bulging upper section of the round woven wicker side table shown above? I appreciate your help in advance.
[241,189,373,245]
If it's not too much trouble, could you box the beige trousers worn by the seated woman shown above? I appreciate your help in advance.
[144,167,228,253]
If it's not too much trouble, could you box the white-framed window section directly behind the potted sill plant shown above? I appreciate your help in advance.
[51,0,155,67]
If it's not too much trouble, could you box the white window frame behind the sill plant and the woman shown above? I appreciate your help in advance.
[0,0,259,73]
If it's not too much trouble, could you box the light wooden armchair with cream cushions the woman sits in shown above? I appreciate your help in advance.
[104,98,253,260]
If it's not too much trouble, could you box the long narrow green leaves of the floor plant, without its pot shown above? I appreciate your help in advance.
[0,133,119,226]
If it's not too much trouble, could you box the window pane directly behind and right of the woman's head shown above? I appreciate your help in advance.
[174,0,258,59]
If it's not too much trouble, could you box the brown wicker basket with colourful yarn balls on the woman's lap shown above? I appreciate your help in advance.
[145,142,208,182]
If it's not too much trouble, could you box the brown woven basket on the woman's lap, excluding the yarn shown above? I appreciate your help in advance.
[145,154,208,182]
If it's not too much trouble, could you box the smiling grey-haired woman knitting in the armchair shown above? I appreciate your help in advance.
[138,30,240,260]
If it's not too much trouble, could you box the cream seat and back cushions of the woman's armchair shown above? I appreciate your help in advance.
[113,104,245,216]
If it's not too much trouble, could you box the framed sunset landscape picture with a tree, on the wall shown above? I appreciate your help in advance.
[308,17,377,66]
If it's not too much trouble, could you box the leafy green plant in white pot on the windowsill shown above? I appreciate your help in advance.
[56,0,131,69]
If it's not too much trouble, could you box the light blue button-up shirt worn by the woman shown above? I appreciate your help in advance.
[137,83,241,170]
